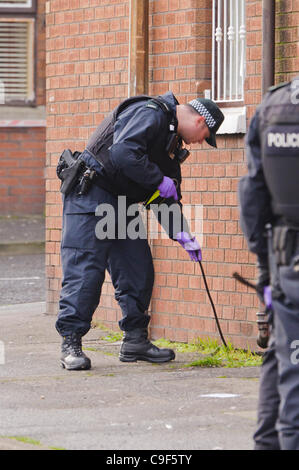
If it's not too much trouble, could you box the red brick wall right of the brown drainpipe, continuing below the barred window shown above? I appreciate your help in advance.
[151,1,244,341]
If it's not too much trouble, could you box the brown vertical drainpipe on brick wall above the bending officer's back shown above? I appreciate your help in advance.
[128,0,149,96]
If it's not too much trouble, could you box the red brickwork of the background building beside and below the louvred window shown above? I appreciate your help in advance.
[0,0,46,215]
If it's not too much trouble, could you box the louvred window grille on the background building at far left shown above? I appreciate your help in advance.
[0,19,34,104]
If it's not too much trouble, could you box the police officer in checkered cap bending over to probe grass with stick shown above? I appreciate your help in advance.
[56,92,223,370]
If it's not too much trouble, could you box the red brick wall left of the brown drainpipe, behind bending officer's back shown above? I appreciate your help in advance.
[46,0,129,312]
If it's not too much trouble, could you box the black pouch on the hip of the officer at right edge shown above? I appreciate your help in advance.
[273,225,299,266]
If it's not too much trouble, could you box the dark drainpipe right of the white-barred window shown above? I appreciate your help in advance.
[262,0,275,95]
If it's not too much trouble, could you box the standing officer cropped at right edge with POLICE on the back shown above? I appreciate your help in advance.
[239,77,299,450]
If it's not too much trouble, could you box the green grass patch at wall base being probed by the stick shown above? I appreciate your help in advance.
[154,338,262,368]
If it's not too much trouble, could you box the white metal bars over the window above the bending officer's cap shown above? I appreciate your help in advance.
[212,0,246,102]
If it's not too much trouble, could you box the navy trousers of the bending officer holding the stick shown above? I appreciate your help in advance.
[56,188,154,336]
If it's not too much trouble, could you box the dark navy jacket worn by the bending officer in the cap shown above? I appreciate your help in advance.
[66,92,188,238]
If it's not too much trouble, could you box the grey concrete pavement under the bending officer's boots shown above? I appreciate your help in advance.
[0,302,259,450]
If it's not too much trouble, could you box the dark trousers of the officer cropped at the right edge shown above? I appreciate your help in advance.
[254,244,299,450]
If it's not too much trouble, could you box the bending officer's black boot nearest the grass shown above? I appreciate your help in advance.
[119,328,175,363]
